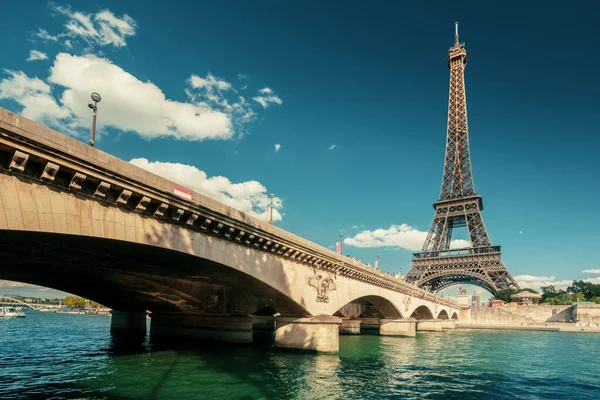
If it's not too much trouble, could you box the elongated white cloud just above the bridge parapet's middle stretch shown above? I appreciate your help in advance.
[130,158,283,221]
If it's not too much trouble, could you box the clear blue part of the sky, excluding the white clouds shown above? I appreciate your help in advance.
[0,0,600,296]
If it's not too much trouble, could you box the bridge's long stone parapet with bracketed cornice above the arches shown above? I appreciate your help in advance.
[0,108,457,308]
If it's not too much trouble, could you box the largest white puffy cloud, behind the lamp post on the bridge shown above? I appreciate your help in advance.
[0,53,255,140]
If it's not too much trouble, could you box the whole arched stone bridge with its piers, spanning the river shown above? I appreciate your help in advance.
[0,108,459,352]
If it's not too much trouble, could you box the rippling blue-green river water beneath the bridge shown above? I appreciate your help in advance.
[0,311,600,399]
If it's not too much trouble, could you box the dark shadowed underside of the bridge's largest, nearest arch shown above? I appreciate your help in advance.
[0,231,310,316]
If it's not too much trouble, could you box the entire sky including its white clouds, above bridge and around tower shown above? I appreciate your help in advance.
[0,0,600,298]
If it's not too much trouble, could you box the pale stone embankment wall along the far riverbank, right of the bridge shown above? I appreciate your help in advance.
[464,305,576,324]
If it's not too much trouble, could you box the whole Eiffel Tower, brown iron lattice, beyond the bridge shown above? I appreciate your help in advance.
[405,22,519,295]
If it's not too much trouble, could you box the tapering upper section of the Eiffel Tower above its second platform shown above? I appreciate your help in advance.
[440,22,475,200]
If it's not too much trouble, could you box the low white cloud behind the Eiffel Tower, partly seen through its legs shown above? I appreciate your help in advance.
[344,224,471,251]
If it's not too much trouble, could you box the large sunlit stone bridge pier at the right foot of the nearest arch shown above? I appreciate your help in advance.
[275,315,342,353]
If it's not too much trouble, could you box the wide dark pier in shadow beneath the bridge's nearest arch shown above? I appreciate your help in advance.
[150,312,252,343]
